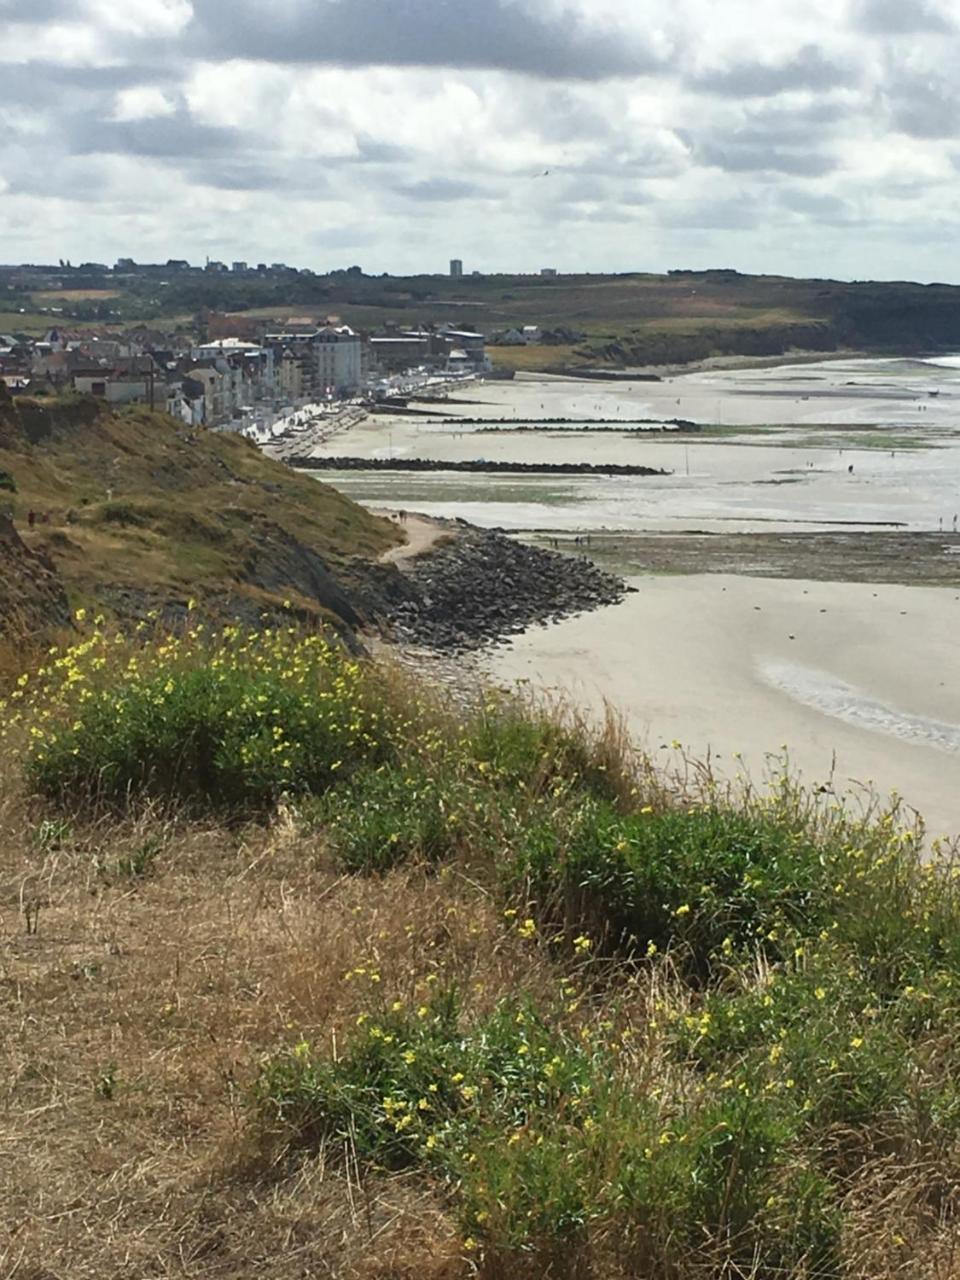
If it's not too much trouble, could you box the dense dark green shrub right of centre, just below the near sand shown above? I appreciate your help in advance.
[507,799,835,973]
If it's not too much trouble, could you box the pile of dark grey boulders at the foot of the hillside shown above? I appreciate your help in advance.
[355,524,628,653]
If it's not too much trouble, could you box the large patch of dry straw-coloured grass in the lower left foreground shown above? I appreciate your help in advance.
[0,747,560,1280]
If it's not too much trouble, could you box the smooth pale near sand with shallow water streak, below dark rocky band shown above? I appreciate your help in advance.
[486,575,960,837]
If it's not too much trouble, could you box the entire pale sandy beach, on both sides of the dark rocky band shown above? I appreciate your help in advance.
[313,357,960,838]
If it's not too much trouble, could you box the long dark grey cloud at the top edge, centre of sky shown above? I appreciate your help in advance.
[187,0,662,79]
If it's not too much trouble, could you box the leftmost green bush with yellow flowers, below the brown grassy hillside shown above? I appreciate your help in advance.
[18,628,387,810]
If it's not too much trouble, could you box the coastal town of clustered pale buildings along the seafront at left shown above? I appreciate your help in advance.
[0,259,578,443]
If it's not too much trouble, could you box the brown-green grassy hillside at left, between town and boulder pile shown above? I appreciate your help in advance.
[0,383,401,630]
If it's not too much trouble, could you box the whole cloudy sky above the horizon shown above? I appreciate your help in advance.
[0,0,960,282]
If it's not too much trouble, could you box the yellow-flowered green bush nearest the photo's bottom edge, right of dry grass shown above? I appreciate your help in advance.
[257,991,840,1274]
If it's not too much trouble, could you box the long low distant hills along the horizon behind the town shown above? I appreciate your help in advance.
[9,270,960,369]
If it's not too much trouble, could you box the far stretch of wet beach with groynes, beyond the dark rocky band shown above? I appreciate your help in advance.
[315,361,960,532]
